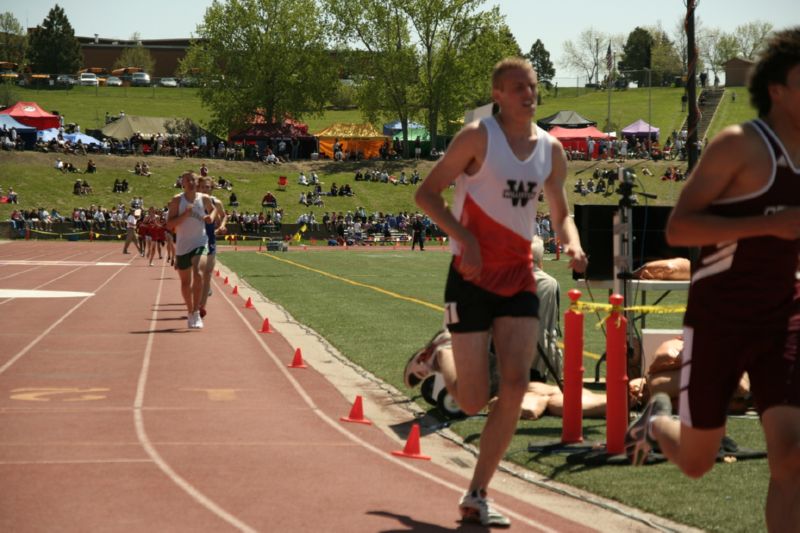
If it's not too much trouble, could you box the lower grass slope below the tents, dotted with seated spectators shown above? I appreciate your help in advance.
[0,152,685,222]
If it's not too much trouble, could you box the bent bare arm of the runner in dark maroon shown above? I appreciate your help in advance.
[667,126,800,246]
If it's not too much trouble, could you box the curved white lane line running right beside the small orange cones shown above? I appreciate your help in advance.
[217,284,559,533]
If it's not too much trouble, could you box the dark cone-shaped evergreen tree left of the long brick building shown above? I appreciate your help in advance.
[28,4,83,74]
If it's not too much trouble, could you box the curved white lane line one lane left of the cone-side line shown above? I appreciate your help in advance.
[133,266,256,533]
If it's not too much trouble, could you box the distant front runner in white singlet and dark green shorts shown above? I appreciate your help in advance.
[167,172,216,329]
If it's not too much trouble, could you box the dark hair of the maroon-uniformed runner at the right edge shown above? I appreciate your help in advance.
[747,26,800,117]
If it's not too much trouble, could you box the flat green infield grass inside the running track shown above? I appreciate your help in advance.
[219,246,768,532]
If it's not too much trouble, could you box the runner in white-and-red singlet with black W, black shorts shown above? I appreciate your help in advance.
[411,58,586,526]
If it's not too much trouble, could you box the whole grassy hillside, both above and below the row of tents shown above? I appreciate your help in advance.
[0,82,755,221]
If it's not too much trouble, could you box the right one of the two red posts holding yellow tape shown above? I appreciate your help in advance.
[606,294,628,454]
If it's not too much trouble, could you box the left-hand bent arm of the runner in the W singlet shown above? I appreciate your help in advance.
[414,122,488,281]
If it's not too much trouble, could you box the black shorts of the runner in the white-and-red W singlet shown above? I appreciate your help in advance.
[444,262,539,333]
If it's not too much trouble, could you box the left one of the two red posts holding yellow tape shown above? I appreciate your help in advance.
[561,289,583,444]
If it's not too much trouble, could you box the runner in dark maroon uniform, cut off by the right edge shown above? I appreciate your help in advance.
[626,28,800,531]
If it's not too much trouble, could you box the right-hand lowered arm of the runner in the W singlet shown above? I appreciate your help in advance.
[544,143,587,272]
